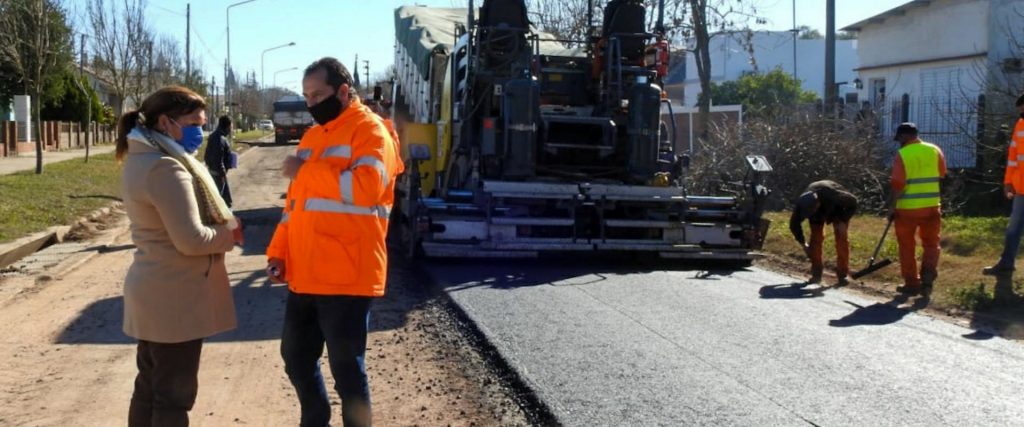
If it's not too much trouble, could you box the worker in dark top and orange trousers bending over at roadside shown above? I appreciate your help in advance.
[790,180,857,286]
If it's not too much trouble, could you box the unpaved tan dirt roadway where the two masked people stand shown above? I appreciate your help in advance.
[0,147,535,426]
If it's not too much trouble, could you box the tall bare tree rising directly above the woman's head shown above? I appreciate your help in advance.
[86,0,153,117]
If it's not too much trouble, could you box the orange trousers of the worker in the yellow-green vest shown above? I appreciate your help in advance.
[895,208,942,288]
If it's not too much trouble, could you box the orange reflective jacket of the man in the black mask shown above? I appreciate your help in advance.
[266,98,403,297]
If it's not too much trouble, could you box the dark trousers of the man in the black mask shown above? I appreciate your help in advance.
[281,292,372,427]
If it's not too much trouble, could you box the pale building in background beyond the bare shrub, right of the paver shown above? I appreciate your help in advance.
[669,31,857,105]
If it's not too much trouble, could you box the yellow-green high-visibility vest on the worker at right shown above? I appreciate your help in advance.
[896,141,942,209]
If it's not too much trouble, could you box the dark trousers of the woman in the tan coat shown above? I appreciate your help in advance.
[128,340,203,427]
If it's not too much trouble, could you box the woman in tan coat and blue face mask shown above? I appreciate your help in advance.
[117,87,242,426]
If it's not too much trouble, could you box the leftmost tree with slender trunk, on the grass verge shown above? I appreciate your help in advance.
[0,0,72,174]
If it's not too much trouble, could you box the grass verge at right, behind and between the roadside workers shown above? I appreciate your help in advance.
[764,212,1024,310]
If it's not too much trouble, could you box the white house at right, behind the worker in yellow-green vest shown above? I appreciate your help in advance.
[843,0,1024,168]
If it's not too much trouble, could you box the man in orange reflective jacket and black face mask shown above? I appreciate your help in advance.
[266,57,402,426]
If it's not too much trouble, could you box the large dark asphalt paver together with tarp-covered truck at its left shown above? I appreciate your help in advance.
[392,0,771,260]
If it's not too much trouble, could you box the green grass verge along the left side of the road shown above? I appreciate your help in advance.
[0,154,121,243]
